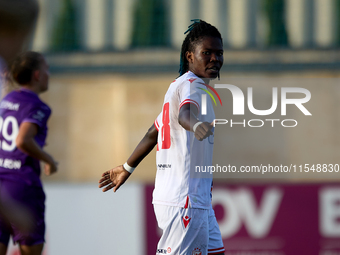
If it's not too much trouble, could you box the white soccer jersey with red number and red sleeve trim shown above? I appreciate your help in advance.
[153,71,215,209]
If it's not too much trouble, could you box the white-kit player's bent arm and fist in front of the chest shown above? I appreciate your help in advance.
[178,104,213,141]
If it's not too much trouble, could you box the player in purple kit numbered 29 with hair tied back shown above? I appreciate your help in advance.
[0,52,57,255]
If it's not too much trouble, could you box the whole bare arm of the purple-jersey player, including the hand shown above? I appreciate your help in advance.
[15,122,57,175]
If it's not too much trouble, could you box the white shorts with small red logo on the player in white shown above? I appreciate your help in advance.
[154,204,224,255]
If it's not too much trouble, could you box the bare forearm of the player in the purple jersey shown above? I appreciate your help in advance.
[16,137,53,164]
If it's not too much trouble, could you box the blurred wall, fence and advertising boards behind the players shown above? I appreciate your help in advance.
[3,0,340,255]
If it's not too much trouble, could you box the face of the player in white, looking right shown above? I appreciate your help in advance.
[186,37,223,79]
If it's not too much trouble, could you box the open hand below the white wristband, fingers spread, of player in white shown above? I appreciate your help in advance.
[98,165,131,192]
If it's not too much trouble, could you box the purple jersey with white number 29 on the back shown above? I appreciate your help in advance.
[0,89,51,186]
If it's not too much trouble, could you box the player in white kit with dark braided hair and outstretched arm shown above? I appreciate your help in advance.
[99,20,224,255]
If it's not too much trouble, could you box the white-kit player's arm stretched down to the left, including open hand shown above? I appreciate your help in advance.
[99,122,158,192]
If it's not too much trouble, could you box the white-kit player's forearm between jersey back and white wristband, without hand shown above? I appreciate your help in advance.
[127,125,158,167]
